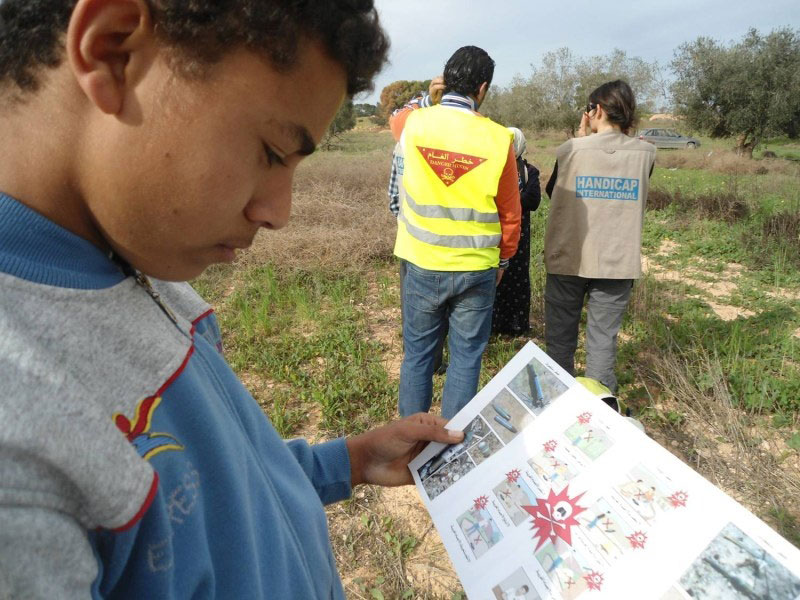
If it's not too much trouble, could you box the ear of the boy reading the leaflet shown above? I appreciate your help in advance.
[66,0,153,115]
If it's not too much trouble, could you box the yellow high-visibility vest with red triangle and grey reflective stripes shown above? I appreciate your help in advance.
[394,105,513,271]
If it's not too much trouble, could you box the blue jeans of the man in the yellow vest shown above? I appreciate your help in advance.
[398,263,497,419]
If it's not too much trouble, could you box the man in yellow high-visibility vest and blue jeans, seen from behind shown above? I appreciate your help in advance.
[390,46,521,418]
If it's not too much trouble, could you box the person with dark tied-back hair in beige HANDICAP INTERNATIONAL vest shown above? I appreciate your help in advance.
[544,80,656,393]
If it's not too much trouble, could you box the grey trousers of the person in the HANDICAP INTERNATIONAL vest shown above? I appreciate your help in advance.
[544,273,633,394]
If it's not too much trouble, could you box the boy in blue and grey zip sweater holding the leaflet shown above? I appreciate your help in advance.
[0,0,460,598]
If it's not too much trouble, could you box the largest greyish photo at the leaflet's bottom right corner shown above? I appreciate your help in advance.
[662,523,800,600]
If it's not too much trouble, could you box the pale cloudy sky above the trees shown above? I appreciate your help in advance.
[356,0,800,103]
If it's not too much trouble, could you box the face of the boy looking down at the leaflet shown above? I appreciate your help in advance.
[78,42,346,280]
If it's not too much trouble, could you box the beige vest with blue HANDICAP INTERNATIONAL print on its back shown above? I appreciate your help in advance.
[544,131,656,279]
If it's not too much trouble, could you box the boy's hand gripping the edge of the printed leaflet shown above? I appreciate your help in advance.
[347,413,464,486]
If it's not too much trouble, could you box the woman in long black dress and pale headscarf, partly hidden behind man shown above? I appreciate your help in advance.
[492,127,542,335]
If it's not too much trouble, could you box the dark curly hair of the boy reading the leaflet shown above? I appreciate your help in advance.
[0,0,389,95]
